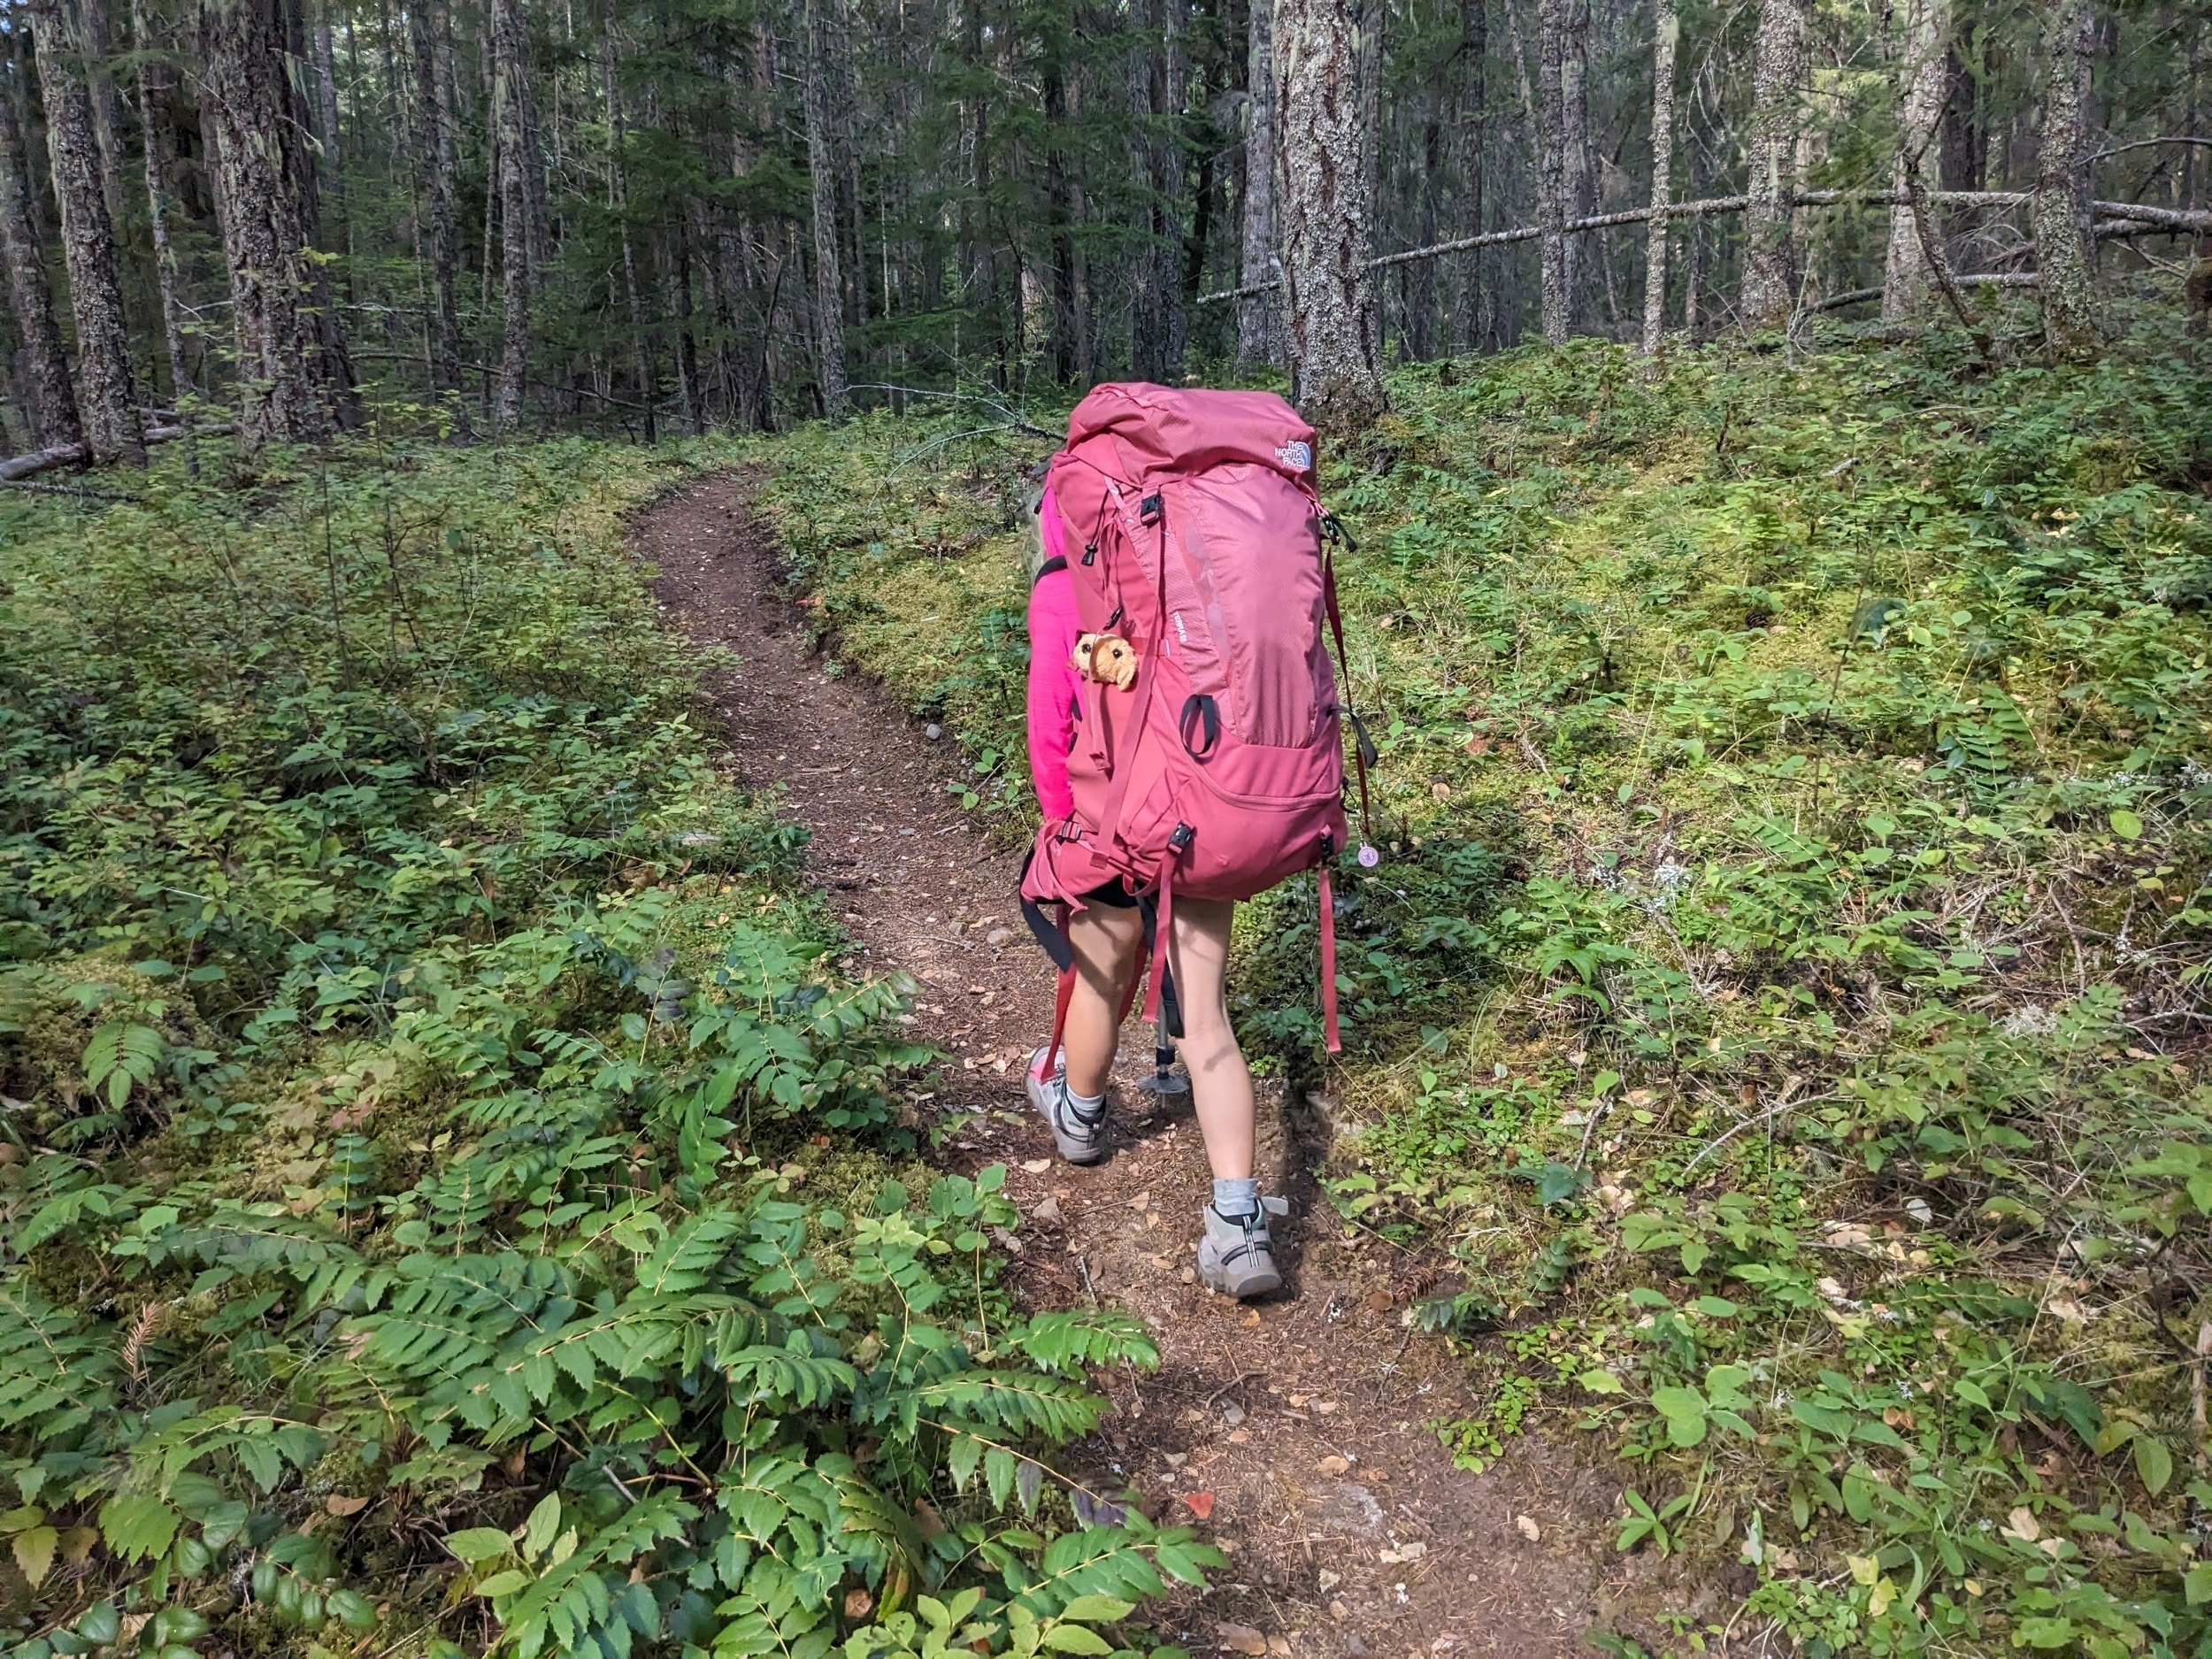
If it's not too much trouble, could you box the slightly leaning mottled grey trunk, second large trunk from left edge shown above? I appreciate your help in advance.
[31,0,146,467]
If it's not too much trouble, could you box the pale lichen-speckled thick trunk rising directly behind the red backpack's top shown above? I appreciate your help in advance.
[1274,0,1389,434]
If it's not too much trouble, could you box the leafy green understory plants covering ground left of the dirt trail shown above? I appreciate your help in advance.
[0,442,1219,1659]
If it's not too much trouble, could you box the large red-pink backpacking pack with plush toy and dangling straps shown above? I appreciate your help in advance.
[1022,383,1371,1069]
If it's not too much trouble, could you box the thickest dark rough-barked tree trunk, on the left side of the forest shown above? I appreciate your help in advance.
[199,0,349,447]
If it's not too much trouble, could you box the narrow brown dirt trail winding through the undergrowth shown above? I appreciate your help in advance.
[633,476,1732,1659]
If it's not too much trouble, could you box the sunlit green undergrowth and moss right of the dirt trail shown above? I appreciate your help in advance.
[739,314,2212,1659]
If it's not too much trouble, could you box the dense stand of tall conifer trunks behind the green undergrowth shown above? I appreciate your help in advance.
[0,0,2212,456]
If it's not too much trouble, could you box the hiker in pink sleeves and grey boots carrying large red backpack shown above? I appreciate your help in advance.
[1022,385,1374,1296]
